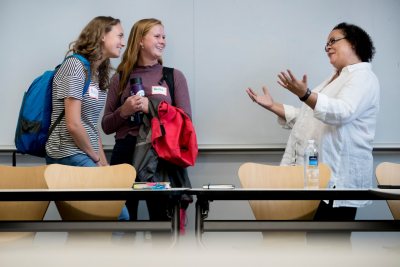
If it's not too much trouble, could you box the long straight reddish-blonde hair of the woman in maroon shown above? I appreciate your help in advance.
[117,18,162,94]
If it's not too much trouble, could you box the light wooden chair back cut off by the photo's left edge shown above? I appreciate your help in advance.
[0,165,50,243]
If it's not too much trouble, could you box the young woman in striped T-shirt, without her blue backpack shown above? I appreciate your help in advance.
[46,16,125,167]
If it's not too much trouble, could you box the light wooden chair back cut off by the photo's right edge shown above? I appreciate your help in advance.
[375,162,400,220]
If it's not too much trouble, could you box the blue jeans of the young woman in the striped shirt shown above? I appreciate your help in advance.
[46,154,129,221]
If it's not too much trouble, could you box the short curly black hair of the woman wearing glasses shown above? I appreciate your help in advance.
[333,22,375,62]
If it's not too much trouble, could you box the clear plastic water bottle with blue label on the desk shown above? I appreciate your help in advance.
[304,140,319,189]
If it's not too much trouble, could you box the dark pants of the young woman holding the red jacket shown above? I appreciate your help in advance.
[110,135,169,221]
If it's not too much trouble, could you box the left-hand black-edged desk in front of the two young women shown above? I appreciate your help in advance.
[0,188,186,242]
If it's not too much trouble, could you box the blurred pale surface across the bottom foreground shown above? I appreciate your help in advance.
[0,232,400,267]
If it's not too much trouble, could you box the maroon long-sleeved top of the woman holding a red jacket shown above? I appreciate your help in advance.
[101,64,192,139]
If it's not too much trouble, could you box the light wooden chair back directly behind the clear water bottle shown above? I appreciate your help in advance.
[238,163,331,220]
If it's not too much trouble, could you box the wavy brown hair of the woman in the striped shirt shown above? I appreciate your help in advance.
[67,16,121,90]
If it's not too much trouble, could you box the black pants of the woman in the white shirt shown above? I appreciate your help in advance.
[307,200,357,248]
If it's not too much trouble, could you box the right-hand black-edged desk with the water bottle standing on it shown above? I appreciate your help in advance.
[189,189,400,241]
